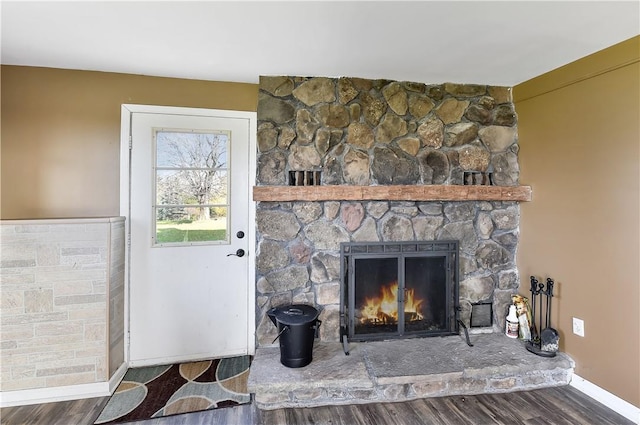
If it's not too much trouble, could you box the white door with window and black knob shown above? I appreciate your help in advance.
[129,107,255,366]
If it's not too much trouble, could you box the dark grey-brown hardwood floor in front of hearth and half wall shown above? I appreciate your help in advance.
[0,386,633,425]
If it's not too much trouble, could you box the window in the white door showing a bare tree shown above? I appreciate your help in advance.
[153,130,230,245]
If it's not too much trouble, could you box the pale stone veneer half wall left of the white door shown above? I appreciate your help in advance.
[0,217,124,392]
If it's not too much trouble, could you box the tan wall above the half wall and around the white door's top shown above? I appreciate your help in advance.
[0,66,258,219]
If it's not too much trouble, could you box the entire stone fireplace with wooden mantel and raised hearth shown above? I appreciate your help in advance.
[248,76,573,409]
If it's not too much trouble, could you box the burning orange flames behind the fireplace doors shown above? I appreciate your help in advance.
[360,282,424,324]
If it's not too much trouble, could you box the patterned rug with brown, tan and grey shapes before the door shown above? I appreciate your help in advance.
[95,356,251,425]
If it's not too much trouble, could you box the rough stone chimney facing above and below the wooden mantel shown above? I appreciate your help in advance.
[256,76,519,346]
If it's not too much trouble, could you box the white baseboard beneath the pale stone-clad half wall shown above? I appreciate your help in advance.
[0,363,127,407]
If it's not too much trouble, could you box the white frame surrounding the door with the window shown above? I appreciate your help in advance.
[120,104,257,365]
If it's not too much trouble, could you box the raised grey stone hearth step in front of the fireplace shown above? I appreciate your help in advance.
[248,333,574,410]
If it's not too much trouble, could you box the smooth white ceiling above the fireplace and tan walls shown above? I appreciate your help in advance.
[0,0,640,86]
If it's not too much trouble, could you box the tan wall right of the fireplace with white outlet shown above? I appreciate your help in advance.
[514,37,640,406]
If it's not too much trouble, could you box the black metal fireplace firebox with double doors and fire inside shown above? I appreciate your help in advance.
[340,241,459,353]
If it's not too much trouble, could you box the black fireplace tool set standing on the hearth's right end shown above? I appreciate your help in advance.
[526,276,560,357]
